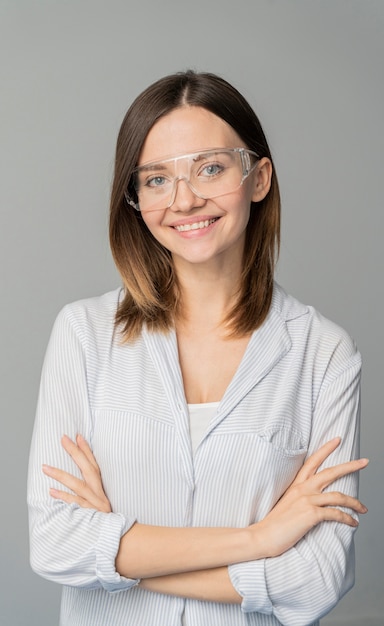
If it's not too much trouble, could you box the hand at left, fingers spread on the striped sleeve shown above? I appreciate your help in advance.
[43,435,112,513]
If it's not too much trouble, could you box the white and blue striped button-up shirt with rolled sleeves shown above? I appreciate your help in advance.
[28,285,361,626]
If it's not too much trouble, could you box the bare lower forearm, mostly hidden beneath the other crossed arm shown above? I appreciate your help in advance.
[139,567,242,604]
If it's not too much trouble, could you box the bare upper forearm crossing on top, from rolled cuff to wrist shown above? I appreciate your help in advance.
[116,524,265,578]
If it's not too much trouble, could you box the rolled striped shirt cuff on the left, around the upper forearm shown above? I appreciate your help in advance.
[96,513,140,593]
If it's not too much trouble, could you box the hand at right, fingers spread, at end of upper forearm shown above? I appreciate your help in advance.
[254,438,369,557]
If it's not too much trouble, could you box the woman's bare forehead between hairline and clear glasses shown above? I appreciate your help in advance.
[138,106,246,165]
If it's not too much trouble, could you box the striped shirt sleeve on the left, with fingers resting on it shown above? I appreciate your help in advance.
[28,307,139,592]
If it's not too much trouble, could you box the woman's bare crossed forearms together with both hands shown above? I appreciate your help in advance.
[43,435,368,603]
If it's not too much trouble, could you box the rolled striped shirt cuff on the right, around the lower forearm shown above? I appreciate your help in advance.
[228,559,272,615]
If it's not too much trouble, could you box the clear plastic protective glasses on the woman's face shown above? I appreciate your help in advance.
[125,148,260,211]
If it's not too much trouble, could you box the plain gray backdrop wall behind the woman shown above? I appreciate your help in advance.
[0,0,384,626]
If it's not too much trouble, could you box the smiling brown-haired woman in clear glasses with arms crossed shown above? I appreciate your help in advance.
[29,71,367,626]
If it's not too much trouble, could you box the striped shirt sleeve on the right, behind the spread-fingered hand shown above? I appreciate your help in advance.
[229,342,361,626]
